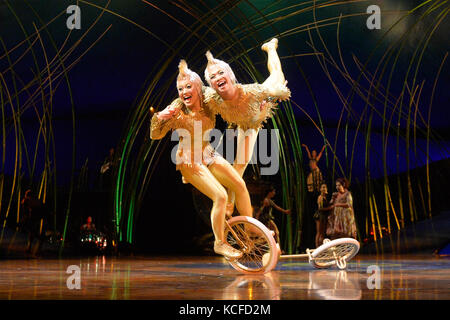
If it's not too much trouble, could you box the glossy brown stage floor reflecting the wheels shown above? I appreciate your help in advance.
[0,255,450,300]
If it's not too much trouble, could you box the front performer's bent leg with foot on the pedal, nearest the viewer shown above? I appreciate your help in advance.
[180,165,242,258]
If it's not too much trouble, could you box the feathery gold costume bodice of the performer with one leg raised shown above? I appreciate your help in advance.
[203,83,290,131]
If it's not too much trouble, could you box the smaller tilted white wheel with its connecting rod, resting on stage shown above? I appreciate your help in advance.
[280,238,359,270]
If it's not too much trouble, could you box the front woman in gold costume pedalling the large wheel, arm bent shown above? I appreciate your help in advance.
[150,60,253,259]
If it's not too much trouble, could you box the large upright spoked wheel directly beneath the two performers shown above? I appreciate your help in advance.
[224,216,279,274]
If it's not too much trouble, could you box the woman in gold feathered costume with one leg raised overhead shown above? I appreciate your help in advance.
[204,38,290,209]
